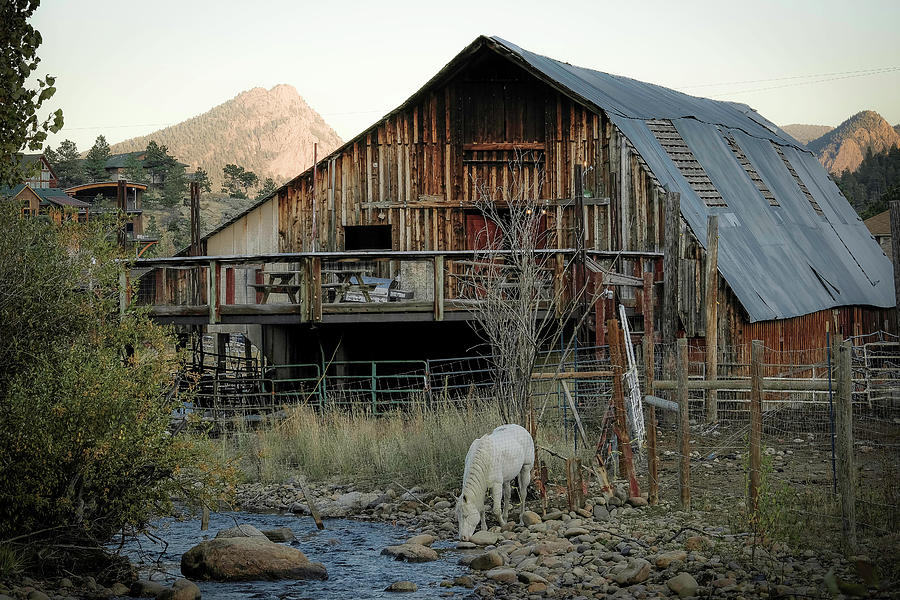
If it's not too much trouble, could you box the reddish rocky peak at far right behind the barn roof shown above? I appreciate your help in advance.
[804,110,900,174]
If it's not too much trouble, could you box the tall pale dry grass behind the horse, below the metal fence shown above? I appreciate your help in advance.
[214,403,588,490]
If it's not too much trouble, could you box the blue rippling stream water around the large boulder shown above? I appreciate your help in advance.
[118,512,465,600]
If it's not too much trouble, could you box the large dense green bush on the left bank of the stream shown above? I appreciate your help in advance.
[0,204,231,569]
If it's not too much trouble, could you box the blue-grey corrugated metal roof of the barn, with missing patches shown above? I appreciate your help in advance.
[490,37,894,321]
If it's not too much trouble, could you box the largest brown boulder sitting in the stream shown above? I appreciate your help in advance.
[181,536,328,581]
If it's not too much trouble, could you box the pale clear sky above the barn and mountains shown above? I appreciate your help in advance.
[32,0,900,150]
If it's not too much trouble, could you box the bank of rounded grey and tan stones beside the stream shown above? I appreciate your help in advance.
[239,482,884,599]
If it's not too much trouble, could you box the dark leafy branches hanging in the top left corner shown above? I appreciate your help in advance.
[0,0,63,187]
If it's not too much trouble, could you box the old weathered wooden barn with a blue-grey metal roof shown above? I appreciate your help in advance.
[176,37,895,366]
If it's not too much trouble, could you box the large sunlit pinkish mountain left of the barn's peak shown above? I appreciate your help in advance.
[111,84,341,191]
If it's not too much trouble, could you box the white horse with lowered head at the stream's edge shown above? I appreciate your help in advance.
[456,424,534,541]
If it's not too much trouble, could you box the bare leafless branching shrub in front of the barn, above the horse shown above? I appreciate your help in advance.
[460,156,584,425]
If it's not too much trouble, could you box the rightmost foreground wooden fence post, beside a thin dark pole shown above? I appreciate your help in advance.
[835,335,856,551]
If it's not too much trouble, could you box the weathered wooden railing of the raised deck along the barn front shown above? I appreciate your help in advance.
[121,249,659,324]
